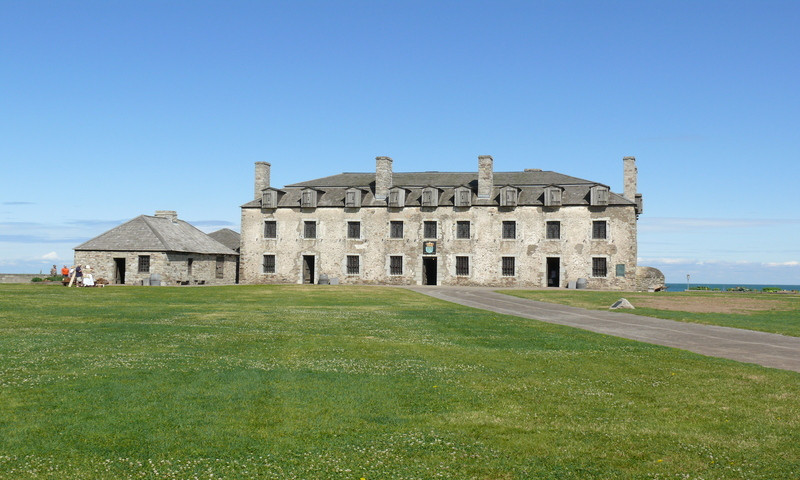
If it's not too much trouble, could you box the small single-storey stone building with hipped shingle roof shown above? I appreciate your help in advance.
[75,210,238,285]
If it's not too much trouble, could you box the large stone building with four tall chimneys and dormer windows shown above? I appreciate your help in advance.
[240,156,643,290]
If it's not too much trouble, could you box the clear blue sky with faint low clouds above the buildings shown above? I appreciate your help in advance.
[0,0,800,284]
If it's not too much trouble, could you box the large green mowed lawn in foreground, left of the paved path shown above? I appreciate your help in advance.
[0,285,800,480]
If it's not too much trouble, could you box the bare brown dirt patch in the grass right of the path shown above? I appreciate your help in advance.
[631,295,798,313]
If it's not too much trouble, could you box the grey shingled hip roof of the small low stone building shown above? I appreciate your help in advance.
[75,215,237,255]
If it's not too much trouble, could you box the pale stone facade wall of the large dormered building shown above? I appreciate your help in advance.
[240,201,637,290]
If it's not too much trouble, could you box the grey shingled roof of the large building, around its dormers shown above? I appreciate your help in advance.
[242,171,634,208]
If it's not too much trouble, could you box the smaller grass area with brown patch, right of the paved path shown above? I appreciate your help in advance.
[500,290,800,337]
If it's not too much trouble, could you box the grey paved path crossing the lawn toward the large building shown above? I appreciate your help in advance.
[408,286,800,372]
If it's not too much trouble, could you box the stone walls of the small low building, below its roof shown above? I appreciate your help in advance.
[75,251,236,285]
